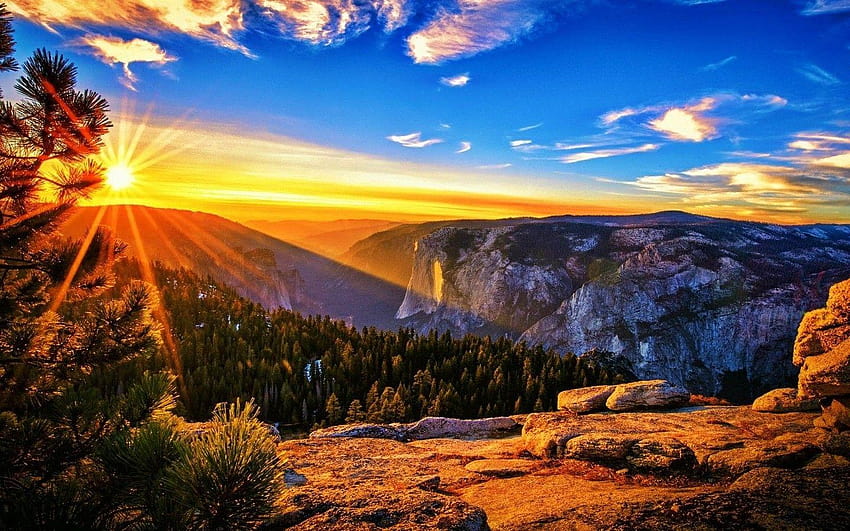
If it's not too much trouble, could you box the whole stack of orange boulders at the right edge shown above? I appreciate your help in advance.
[794,280,850,430]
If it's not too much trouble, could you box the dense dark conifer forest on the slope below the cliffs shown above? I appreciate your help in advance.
[93,261,623,429]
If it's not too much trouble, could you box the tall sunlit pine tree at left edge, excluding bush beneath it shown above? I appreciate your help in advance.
[0,5,156,409]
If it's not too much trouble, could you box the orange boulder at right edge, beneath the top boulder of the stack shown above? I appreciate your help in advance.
[797,338,850,398]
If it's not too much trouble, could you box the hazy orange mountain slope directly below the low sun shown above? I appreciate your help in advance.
[61,206,404,328]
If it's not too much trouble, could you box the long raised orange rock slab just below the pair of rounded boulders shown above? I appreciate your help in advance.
[522,406,825,476]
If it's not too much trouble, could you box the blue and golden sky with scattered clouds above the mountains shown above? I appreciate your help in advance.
[0,0,850,222]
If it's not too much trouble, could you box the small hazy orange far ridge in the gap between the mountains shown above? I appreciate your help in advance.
[245,219,400,258]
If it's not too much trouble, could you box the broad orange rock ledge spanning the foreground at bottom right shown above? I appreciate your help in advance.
[266,406,850,530]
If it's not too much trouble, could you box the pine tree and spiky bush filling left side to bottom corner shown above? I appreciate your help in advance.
[0,4,280,529]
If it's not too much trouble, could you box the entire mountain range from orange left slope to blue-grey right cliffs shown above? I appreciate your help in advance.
[67,207,850,402]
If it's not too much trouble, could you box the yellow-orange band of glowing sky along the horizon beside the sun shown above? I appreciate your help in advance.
[78,108,850,227]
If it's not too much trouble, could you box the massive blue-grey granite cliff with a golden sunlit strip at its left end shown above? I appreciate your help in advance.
[396,213,850,401]
